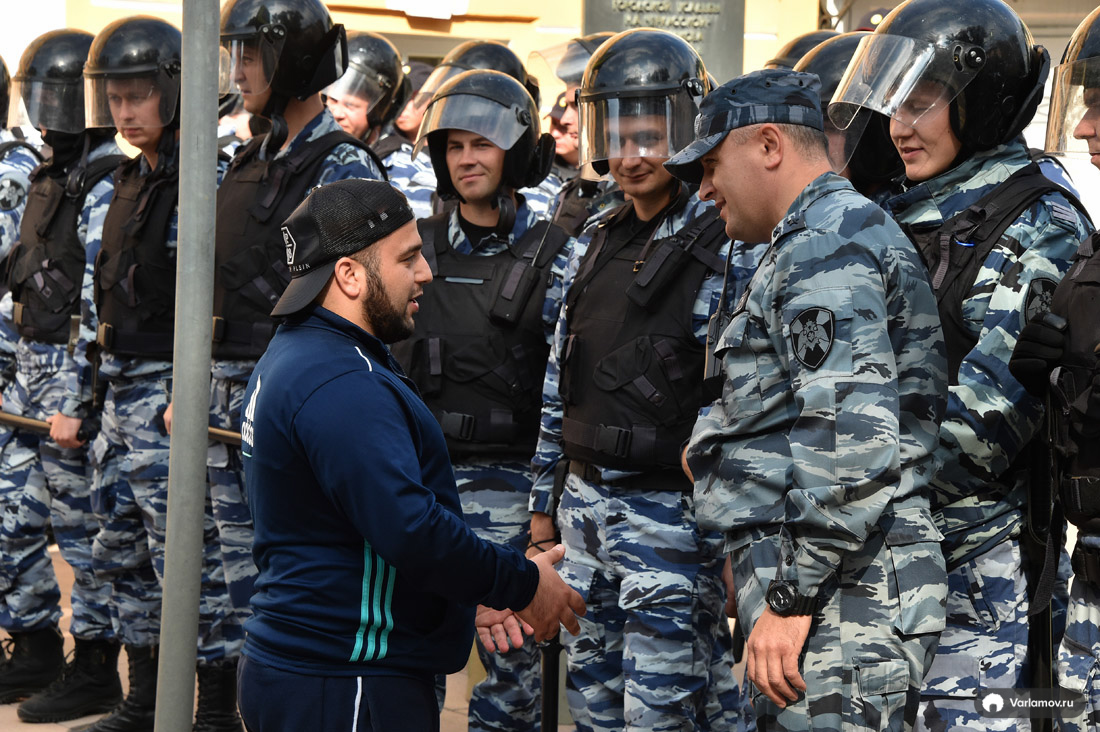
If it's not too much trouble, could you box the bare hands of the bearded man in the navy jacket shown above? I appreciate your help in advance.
[474,544,586,653]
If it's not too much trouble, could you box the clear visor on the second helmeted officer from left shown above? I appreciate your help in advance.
[84,73,179,130]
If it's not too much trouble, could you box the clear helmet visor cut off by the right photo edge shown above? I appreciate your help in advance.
[1044,57,1100,160]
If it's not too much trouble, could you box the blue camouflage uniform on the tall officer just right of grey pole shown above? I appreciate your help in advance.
[207,109,382,658]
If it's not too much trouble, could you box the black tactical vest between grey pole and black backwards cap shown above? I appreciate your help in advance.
[213,130,385,359]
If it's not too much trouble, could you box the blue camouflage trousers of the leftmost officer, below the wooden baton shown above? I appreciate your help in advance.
[0,351,113,640]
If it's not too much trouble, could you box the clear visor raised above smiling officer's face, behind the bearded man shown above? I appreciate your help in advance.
[413,94,538,157]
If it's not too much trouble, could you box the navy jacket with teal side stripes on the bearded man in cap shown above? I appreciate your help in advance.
[241,306,538,676]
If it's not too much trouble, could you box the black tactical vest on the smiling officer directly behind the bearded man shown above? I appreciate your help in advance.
[392,214,569,459]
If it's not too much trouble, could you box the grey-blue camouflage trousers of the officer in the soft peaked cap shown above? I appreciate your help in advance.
[730,501,946,732]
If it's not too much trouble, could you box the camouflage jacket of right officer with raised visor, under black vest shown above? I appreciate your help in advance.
[887,142,1091,566]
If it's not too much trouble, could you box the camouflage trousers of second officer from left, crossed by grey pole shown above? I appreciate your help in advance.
[92,375,240,664]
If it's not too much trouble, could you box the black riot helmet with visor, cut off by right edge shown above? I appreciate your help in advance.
[1045,8,1100,160]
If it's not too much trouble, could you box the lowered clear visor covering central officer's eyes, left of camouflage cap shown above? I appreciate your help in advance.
[580,91,696,165]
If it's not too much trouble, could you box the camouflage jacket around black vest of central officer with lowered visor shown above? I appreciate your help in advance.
[528,196,765,514]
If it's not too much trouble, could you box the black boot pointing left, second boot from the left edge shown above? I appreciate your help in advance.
[19,638,122,722]
